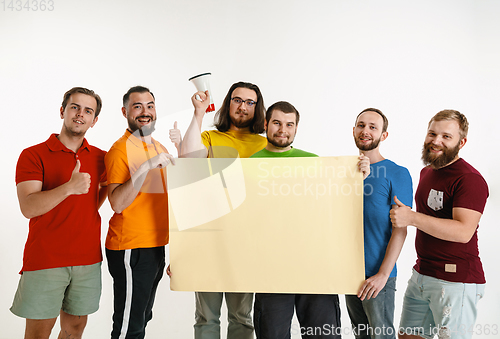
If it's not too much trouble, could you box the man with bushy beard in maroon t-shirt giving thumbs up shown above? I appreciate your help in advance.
[390,110,488,339]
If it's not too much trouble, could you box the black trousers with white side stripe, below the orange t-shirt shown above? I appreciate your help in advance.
[106,246,165,339]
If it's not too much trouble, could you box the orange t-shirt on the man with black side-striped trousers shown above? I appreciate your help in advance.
[104,130,168,250]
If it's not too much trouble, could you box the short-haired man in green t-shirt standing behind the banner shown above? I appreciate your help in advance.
[250,101,370,339]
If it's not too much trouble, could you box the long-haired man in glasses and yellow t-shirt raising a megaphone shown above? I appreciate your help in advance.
[179,82,267,339]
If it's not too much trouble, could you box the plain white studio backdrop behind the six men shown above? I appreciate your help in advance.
[0,0,500,339]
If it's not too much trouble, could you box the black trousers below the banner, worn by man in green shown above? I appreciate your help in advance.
[254,293,342,339]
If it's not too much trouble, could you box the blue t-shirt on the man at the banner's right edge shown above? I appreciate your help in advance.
[363,159,413,277]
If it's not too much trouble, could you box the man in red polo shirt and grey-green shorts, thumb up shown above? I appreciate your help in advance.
[11,87,107,339]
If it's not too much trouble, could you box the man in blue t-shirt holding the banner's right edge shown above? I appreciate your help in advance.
[346,108,413,339]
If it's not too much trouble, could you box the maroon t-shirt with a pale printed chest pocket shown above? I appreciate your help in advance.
[414,159,488,284]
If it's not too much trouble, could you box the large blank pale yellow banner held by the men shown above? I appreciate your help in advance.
[167,156,364,294]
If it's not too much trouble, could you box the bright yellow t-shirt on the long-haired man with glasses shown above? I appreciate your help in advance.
[201,130,267,158]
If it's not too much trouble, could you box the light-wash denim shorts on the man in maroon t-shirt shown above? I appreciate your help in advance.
[399,270,485,339]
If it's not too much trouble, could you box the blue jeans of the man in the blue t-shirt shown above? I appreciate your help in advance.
[345,277,397,339]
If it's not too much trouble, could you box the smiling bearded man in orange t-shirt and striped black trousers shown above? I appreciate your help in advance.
[104,86,173,339]
